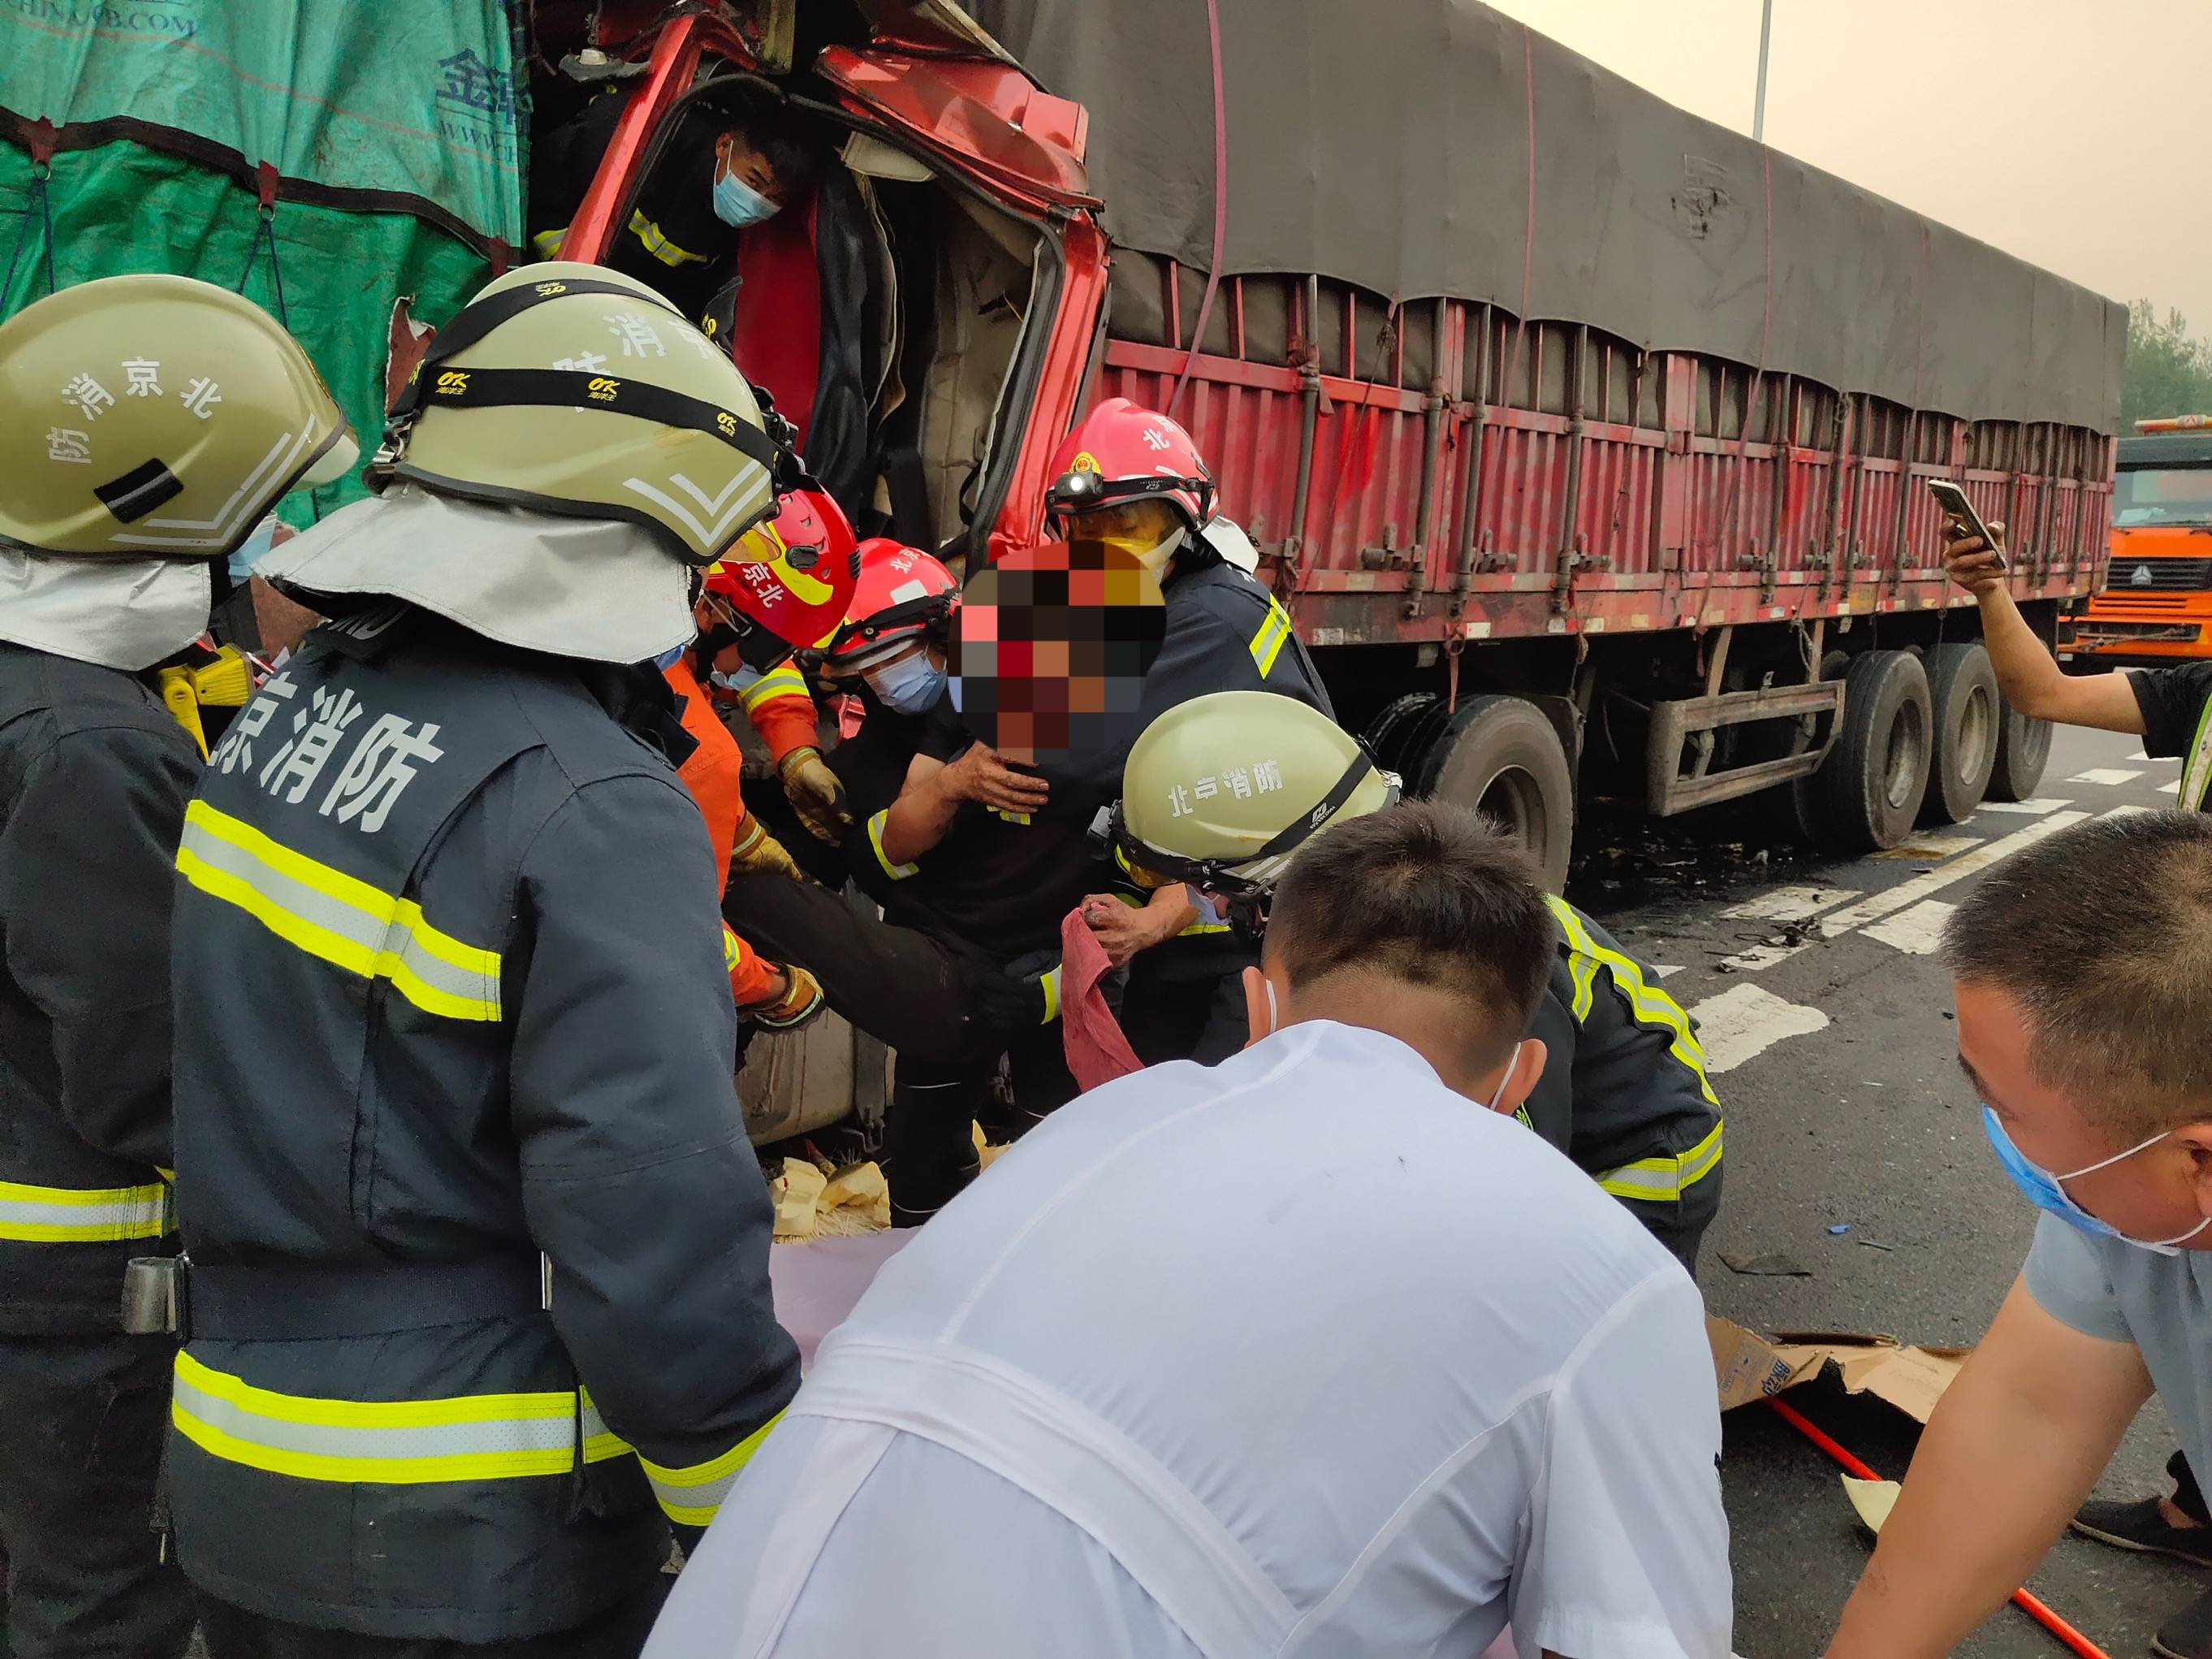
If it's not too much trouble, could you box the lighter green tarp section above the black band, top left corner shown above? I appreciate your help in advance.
[0,0,529,248]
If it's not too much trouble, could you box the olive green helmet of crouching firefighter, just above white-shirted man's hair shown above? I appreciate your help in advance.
[1110,693,1398,898]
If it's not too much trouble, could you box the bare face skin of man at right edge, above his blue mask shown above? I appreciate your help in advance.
[1953,980,2212,1250]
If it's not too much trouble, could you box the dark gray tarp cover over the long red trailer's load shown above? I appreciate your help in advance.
[966,0,2126,431]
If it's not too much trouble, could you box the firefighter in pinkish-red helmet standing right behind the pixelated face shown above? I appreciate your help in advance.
[1046,398,1334,1064]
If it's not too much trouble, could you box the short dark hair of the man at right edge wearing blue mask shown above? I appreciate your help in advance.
[1942,812,2212,1139]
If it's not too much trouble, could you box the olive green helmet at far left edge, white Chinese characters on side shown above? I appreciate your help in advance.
[0,274,361,559]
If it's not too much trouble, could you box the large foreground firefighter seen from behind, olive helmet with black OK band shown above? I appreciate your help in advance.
[171,266,798,1659]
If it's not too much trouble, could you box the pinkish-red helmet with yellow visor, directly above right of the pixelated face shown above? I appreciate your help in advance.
[1044,398,1214,575]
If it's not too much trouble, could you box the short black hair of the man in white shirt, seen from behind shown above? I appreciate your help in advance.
[1268,801,1559,1064]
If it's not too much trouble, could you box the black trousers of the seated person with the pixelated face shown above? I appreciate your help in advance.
[724,876,1075,1225]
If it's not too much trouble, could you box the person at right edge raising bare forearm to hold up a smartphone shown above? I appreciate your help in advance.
[1944,517,2212,1655]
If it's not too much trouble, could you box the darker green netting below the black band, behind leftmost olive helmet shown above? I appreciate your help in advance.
[0,144,491,525]
